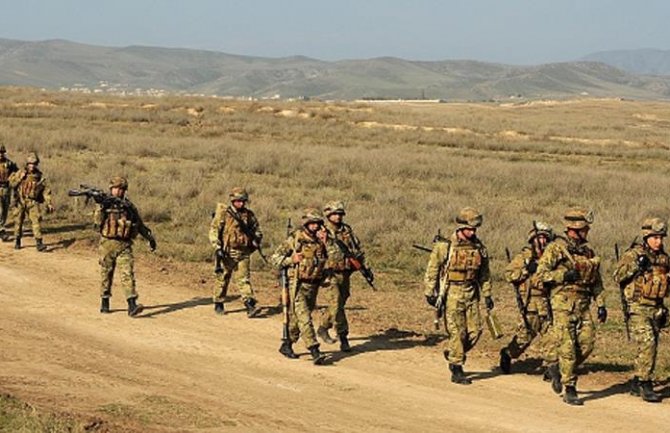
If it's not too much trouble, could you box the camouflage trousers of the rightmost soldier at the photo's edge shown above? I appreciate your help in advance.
[629,303,660,381]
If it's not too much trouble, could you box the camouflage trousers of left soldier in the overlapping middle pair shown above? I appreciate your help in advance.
[288,280,321,347]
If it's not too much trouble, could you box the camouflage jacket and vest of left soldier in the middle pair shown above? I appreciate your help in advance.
[270,228,333,281]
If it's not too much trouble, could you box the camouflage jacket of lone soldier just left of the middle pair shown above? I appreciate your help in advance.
[209,203,263,251]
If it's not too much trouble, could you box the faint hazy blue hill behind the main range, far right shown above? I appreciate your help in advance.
[583,49,670,75]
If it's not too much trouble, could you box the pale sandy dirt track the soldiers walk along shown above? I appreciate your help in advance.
[0,244,670,432]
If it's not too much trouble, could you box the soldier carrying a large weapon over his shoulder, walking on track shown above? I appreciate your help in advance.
[94,176,156,317]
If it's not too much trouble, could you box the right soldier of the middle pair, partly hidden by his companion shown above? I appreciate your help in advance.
[317,201,364,352]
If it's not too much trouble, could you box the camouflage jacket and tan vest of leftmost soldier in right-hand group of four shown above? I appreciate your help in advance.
[423,233,491,297]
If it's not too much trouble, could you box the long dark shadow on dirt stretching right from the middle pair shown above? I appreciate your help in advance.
[321,328,446,365]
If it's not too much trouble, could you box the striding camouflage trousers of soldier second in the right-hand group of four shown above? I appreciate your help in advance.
[507,296,556,362]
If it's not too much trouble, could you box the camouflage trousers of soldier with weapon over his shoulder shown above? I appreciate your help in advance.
[99,238,137,299]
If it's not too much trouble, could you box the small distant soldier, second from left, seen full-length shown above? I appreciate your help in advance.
[9,153,54,251]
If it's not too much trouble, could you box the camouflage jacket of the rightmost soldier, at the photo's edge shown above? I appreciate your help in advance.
[614,244,670,305]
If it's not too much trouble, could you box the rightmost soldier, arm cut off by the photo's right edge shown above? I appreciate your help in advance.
[614,218,670,403]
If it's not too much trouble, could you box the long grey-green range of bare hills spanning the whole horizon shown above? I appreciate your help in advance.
[0,39,670,100]
